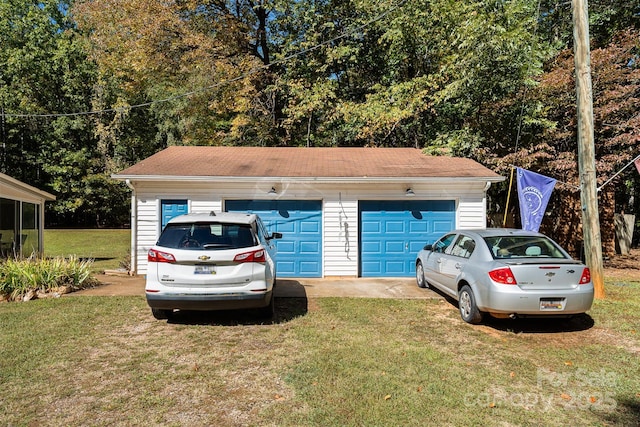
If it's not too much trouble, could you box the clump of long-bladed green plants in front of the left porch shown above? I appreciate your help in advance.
[0,256,94,299]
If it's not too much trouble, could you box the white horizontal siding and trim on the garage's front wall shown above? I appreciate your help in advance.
[131,179,486,277]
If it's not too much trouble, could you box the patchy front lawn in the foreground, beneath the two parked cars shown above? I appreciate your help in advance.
[0,279,640,426]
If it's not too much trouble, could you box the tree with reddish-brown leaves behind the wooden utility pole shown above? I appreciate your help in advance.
[480,29,640,256]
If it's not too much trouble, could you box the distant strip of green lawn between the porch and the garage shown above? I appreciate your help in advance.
[44,229,131,272]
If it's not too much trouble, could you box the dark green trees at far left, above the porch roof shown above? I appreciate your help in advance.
[0,0,128,225]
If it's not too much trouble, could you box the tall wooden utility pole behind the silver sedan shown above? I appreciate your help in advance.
[572,0,604,299]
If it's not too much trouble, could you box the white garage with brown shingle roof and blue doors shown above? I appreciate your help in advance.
[113,146,504,277]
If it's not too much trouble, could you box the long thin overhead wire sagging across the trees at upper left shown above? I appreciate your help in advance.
[0,0,407,118]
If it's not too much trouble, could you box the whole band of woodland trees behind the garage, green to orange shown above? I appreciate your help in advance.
[0,0,640,247]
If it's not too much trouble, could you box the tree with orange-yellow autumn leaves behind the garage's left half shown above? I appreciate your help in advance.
[73,0,273,148]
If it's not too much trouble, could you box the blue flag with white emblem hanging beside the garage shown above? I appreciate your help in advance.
[516,168,556,231]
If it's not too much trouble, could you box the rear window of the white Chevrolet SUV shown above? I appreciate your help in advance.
[158,222,257,250]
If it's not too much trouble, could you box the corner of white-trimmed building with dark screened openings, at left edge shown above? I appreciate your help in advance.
[0,173,56,257]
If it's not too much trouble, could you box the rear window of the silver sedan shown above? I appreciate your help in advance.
[484,236,567,259]
